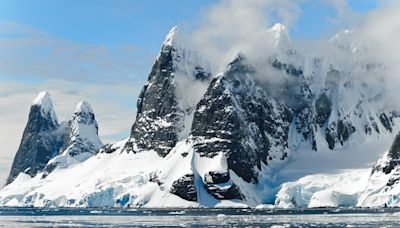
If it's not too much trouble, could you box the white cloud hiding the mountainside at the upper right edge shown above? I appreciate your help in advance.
[336,1,400,107]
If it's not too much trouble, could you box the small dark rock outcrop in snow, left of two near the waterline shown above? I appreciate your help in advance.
[170,174,197,202]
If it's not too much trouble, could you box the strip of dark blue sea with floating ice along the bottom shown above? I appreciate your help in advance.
[0,208,400,227]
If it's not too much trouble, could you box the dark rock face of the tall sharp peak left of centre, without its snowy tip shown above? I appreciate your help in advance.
[126,28,210,157]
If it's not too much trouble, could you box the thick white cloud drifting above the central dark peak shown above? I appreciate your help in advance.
[188,0,302,72]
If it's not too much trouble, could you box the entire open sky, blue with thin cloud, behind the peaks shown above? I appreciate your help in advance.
[0,0,384,183]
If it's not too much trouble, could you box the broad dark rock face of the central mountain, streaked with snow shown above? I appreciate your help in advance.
[192,56,292,183]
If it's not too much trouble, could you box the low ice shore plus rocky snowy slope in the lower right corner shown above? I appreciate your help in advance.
[275,134,400,208]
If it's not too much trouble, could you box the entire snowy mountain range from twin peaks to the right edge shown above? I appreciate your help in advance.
[0,24,400,207]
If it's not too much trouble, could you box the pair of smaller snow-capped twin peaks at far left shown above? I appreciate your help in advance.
[3,91,102,184]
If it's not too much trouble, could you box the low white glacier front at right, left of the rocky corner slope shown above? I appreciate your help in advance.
[275,169,370,208]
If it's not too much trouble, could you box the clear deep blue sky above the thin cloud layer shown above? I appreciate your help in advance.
[0,0,379,52]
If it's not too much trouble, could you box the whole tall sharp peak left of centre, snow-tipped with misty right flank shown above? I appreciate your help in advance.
[126,27,211,156]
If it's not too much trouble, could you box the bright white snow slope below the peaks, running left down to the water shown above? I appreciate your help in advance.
[0,140,250,207]
